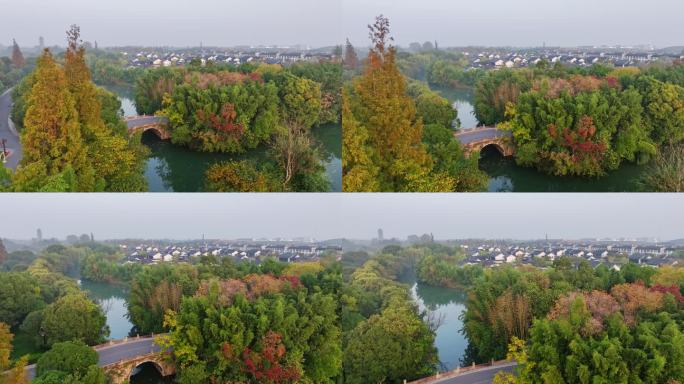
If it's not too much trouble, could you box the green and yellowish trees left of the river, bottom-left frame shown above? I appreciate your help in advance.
[0,244,109,368]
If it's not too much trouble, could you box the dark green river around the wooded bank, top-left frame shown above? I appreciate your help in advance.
[109,87,342,192]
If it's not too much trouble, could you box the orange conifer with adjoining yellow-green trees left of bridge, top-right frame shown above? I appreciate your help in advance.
[342,17,487,192]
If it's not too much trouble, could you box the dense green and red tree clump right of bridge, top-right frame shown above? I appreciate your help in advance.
[475,62,684,177]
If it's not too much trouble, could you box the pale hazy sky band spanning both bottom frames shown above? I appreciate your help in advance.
[0,193,684,240]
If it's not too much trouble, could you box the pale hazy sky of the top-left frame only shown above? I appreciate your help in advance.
[0,0,343,46]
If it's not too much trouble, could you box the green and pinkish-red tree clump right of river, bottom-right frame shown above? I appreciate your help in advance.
[498,267,684,383]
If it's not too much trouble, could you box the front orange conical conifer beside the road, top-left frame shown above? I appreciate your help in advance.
[14,50,94,191]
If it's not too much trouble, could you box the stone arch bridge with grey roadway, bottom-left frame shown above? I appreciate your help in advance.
[26,336,176,384]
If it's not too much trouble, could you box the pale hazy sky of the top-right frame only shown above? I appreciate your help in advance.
[343,0,684,47]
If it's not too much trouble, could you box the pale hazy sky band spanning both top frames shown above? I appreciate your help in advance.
[5,0,684,47]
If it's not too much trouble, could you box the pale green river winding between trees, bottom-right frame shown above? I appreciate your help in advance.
[411,283,468,371]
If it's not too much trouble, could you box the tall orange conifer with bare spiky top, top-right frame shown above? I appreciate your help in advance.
[351,15,432,191]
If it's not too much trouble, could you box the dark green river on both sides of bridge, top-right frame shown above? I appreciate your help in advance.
[432,86,646,192]
